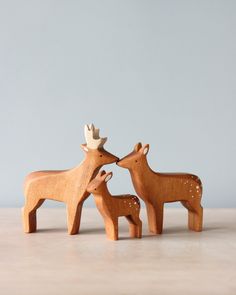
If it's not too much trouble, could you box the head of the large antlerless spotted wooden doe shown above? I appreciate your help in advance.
[117,142,149,169]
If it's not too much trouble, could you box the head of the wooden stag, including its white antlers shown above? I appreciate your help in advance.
[81,124,119,166]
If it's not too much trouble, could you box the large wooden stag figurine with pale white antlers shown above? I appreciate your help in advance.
[22,124,118,235]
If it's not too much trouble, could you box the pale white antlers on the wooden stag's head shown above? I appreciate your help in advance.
[84,124,107,149]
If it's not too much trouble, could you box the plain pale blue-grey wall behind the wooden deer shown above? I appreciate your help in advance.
[0,0,236,207]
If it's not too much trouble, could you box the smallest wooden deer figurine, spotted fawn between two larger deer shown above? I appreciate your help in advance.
[87,171,142,240]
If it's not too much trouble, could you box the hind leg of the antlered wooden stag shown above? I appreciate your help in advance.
[22,199,45,233]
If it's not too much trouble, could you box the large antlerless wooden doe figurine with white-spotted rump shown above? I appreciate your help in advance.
[117,143,203,234]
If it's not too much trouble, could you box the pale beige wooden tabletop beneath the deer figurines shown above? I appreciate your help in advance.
[0,208,236,295]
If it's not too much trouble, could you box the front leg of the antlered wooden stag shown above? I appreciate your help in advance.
[67,202,83,235]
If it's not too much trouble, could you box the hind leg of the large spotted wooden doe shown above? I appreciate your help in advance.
[181,201,203,231]
